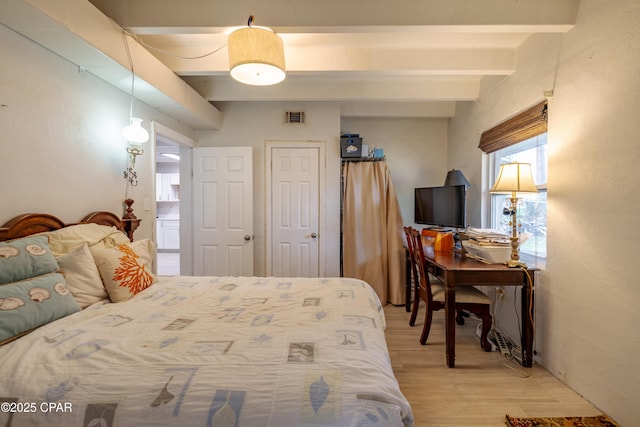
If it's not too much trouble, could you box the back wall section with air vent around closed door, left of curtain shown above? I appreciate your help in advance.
[198,102,340,276]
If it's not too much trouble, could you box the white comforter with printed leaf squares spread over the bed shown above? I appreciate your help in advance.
[0,276,413,427]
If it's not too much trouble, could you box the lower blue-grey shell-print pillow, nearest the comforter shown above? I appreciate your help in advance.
[0,273,80,345]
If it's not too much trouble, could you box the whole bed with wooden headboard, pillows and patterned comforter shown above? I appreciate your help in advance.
[0,212,413,427]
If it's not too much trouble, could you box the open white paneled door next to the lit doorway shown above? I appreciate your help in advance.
[193,147,253,276]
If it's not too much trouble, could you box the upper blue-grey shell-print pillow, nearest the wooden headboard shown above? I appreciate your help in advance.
[0,236,58,284]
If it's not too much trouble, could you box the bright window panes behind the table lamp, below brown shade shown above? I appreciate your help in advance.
[490,132,547,259]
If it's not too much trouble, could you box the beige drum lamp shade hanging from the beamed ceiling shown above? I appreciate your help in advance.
[227,27,285,86]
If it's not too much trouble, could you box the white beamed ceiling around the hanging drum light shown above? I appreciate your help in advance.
[91,0,578,117]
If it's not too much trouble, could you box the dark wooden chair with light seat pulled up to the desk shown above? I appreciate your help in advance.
[405,227,492,351]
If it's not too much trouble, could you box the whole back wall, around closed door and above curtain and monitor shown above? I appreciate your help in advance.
[198,110,447,276]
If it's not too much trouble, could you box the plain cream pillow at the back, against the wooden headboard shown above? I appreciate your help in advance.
[39,223,129,256]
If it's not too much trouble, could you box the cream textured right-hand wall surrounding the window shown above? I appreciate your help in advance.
[448,0,640,426]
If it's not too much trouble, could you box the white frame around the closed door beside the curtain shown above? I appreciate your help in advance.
[264,141,327,277]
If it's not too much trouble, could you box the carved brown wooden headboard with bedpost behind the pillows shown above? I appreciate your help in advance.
[0,199,140,241]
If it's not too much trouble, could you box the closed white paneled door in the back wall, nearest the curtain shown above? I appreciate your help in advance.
[267,146,322,277]
